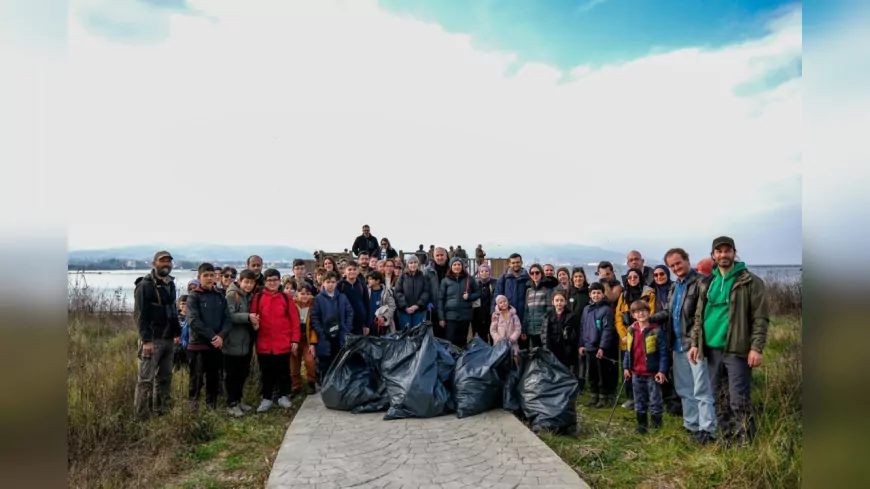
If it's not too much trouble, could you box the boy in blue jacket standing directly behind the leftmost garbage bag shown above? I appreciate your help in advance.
[311,270,354,380]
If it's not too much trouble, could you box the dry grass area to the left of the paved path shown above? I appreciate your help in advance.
[67,280,301,487]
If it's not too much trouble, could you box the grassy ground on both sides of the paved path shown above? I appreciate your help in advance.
[67,272,803,488]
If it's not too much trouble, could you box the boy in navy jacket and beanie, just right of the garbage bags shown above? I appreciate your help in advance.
[578,282,619,408]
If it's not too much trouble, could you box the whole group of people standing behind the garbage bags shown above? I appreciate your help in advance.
[135,226,768,446]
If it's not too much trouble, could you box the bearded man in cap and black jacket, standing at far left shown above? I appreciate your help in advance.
[133,251,181,419]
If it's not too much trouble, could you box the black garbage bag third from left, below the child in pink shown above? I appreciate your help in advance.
[453,337,512,418]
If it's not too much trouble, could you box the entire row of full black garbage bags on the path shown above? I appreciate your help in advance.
[321,322,579,432]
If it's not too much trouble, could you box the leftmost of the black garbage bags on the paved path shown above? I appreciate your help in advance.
[320,335,396,413]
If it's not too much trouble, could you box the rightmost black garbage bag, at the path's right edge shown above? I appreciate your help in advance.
[520,348,580,433]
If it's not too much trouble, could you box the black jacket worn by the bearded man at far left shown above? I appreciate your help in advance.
[133,270,181,341]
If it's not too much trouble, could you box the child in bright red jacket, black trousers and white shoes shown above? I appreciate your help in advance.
[251,268,301,413]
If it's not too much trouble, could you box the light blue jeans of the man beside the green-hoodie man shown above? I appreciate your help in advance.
[674,350,716,433]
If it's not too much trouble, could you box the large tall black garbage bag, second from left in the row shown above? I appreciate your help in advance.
[381,322,455,419]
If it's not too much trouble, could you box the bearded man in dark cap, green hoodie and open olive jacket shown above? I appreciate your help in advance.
[689,236,769,447]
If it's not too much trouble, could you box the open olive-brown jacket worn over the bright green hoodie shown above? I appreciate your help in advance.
[691,269,770,358]
